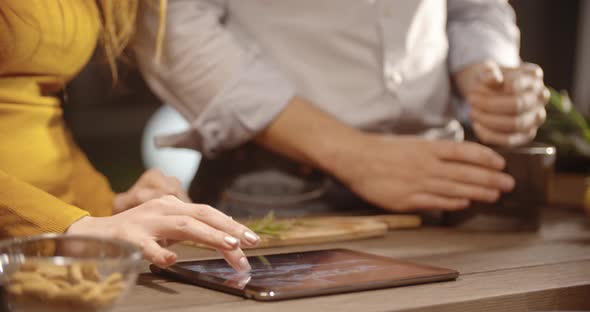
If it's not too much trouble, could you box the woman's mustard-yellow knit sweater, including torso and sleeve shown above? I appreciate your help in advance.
[0,0,113,237]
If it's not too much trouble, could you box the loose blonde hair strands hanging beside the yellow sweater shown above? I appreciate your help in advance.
[96,0,168,83]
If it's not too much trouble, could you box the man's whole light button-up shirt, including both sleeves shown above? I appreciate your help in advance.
[135,0,519,156]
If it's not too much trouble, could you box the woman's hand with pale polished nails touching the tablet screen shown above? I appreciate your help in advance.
[67,196,260,272]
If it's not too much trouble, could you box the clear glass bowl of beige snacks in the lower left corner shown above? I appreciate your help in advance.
[0,234,142,312]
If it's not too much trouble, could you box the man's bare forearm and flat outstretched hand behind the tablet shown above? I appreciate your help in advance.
[257,98,514,211]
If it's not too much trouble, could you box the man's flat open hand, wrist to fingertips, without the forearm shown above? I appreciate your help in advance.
[329,134,514,212]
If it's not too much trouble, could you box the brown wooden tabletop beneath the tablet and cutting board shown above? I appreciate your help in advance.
[117,210,590,312]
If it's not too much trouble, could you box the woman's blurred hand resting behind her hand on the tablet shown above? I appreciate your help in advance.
[113,169,191,214]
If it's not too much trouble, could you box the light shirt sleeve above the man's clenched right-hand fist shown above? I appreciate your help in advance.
[447,0,520,73]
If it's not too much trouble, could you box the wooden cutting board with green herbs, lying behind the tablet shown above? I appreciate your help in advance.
[185,215,421,248]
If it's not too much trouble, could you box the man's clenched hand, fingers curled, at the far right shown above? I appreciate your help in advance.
[455,61,549,146]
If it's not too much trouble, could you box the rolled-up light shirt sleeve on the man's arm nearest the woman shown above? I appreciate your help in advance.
[134,0,295,157]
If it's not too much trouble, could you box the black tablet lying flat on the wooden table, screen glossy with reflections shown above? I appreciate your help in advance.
[150,249,459,301]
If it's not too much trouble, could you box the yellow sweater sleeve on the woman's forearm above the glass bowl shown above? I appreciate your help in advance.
[0,171,89,237]
